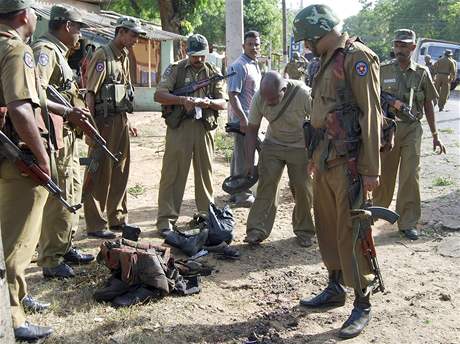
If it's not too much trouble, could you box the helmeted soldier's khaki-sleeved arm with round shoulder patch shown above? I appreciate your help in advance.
[345,51,382,181]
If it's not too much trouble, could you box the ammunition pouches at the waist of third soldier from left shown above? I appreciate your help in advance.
[95,83,134,117]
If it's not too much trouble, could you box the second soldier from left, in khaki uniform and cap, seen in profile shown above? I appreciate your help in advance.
[33,5,94,278]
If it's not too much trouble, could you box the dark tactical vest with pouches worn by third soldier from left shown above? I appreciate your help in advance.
[95,45,134,117]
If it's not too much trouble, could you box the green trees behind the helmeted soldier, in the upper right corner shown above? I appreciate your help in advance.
[344,0,460,60]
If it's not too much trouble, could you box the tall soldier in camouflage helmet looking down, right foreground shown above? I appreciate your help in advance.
[294,5,381,338]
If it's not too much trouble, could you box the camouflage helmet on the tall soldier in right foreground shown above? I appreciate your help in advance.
[294,5,340,42]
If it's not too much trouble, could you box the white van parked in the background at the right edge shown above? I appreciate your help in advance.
[412,38,460,89]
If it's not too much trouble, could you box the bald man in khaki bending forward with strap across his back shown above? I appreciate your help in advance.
[245,72,315,247]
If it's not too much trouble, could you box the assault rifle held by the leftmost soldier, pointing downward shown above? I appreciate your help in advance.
[0,131,81,214]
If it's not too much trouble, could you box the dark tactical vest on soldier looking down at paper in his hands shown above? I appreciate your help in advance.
[162,59,219,131]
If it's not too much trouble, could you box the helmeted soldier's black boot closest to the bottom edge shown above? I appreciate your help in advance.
[339,291,371,339]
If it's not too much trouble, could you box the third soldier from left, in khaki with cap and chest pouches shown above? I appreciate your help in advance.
[83,17,145,238]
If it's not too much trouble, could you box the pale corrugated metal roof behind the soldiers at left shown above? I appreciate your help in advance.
[34,3,187,41]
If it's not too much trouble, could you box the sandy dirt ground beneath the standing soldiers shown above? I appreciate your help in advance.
[28,95,460,344]
